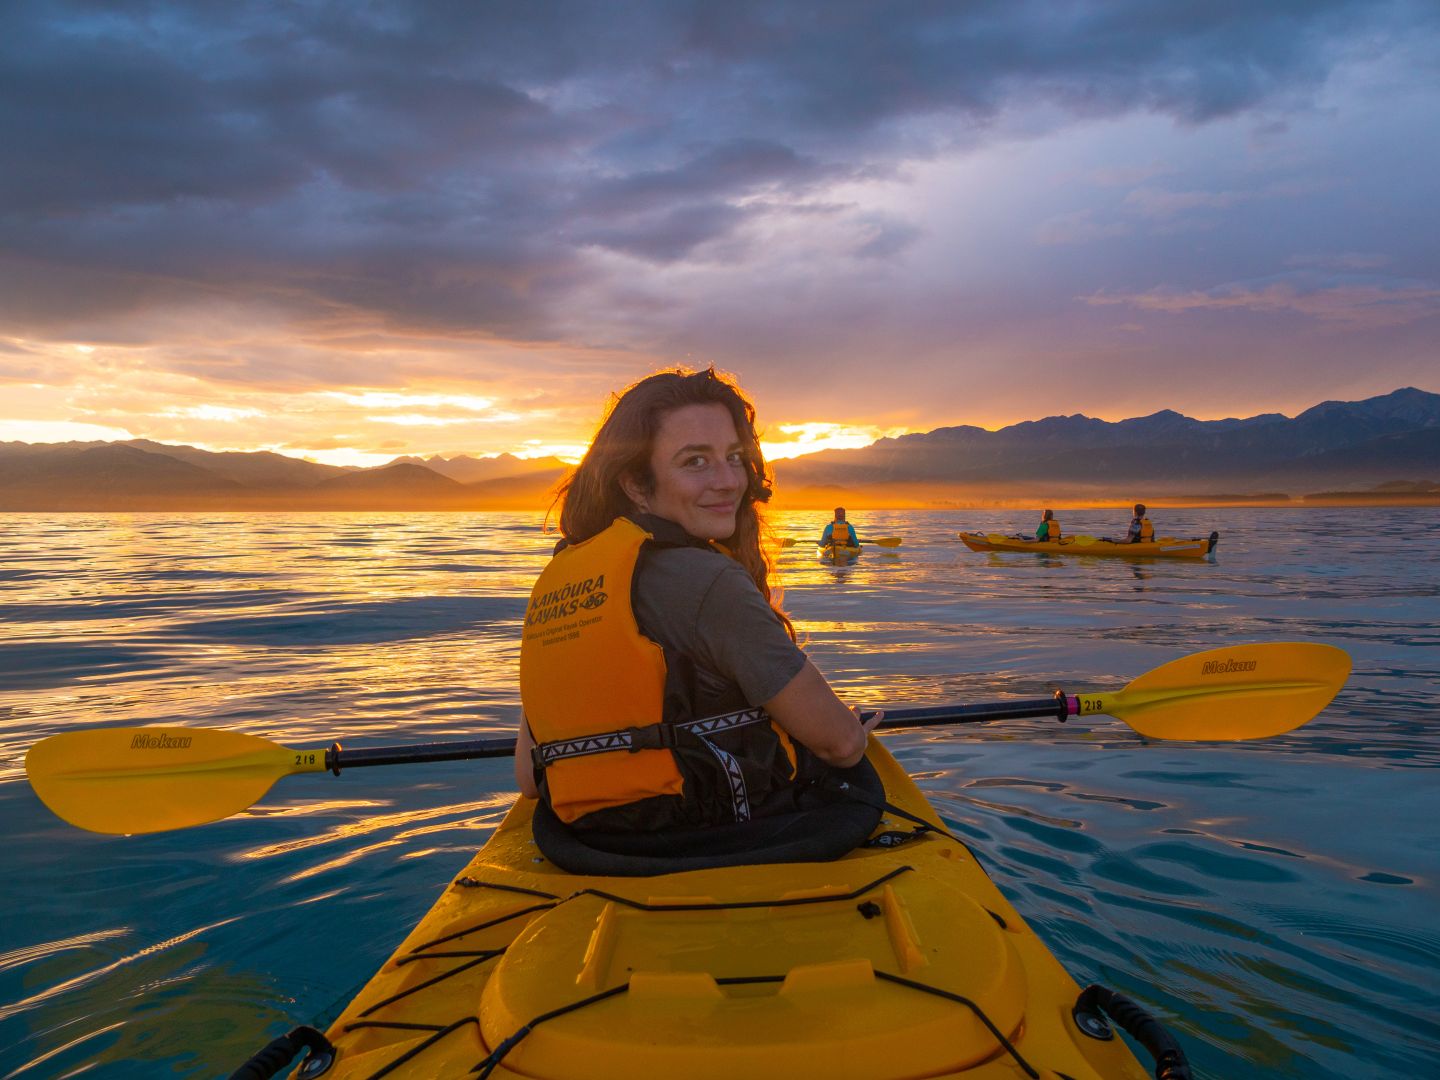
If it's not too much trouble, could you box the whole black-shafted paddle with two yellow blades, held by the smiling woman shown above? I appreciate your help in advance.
[24,642,1351,834]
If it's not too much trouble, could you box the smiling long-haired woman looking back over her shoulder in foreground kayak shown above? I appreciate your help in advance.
[516,369,880,846]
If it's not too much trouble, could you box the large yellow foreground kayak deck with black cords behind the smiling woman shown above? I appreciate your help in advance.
[264,739,1189,1080]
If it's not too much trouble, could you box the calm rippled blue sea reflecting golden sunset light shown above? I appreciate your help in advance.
[0,510,1440,1080]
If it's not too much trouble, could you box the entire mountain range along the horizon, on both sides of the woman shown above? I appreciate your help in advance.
[0,387,1440,511]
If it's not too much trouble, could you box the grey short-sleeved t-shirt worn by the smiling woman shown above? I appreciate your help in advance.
[635,547,805,706]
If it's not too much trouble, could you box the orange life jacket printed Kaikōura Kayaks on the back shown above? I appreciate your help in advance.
[520,517,796,828]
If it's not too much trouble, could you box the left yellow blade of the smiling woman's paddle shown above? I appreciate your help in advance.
[24,727,325,834]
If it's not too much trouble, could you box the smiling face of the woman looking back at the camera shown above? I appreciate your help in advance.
[621,405,747,540]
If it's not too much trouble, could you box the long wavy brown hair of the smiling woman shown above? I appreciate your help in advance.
[552,367,795,639]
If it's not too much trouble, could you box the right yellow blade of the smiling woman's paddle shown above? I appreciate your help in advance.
[1079,641,1351,742]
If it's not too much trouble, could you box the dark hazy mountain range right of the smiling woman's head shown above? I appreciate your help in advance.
[778,387,1440,504]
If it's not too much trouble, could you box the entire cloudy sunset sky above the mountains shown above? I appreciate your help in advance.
[0,0,1440,464]
